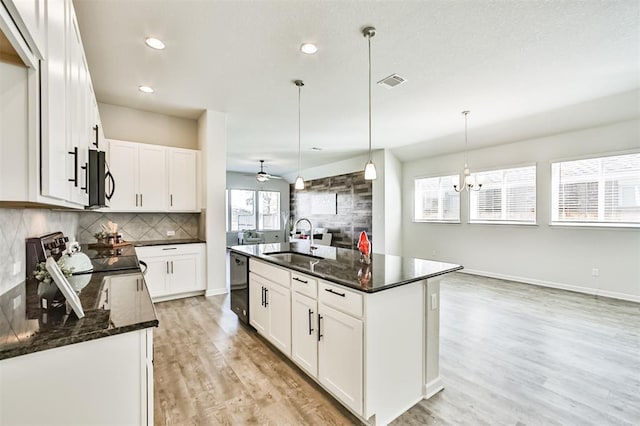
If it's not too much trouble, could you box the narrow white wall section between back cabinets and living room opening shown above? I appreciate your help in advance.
[198,111,227,296]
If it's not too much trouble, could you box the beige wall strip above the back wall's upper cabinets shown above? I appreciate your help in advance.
[98,103,198,149]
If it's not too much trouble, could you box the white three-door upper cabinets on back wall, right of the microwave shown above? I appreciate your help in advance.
[108,140,199,212]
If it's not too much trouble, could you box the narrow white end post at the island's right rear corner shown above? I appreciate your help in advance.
[423,277,444,399]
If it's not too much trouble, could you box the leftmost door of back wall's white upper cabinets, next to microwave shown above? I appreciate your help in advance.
[109,141,139,210]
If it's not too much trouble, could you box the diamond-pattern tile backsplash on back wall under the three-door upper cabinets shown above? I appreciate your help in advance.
[78,212,200,243]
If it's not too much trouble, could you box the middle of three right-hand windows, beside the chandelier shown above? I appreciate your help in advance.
[469,166,536,224]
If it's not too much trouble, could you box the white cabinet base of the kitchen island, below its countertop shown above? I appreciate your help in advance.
[255,259,442,425]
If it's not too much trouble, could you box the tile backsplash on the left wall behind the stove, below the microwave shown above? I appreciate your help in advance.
[0,208,80,294]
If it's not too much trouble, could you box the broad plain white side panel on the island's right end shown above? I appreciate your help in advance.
[363,281,425,424]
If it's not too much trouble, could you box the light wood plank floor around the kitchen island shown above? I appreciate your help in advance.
[154,273,640,425]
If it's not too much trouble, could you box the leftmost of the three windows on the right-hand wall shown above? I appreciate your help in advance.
[414,175,460,222]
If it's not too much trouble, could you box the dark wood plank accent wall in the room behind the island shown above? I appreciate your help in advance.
[289,172,373,248]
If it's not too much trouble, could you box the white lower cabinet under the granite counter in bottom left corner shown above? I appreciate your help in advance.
[0,328,153,426]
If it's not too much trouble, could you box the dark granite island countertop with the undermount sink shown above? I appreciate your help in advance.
[227,240,463,293]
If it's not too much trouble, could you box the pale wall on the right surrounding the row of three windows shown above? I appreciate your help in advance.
[402,119,640,301]
